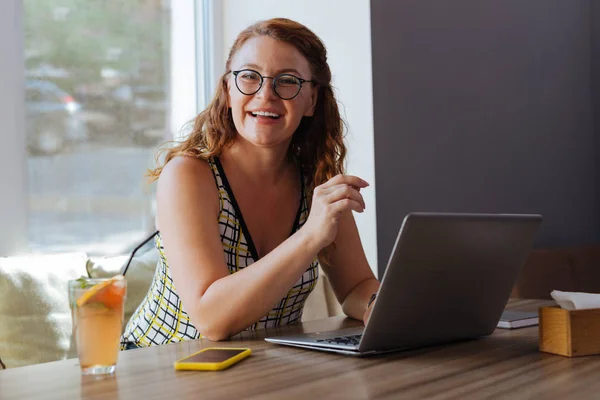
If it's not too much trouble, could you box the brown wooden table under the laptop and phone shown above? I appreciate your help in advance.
[0,300,600,400]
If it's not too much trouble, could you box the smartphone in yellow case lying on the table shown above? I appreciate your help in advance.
[174,347,252,371]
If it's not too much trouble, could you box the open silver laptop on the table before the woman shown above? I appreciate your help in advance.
[265,213,542,356]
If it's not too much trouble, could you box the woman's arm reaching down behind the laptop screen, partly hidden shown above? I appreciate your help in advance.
[321,211,379,323]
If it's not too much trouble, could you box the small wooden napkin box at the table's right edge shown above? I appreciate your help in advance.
[539,307,600,357]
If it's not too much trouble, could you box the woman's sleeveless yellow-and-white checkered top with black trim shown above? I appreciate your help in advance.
[121,158,318,349]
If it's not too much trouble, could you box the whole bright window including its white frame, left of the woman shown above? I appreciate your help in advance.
[0,0,208,256]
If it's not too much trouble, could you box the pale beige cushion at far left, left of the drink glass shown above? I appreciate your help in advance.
[0,253,87,368]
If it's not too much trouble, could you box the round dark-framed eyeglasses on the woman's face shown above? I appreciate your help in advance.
[232,69,313,100]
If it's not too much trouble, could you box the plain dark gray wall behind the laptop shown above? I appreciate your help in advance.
[371,0,600,276]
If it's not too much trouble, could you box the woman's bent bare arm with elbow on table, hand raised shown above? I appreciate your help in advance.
[157,157,362,340]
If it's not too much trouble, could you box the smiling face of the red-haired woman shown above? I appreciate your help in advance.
[227,36,317,149]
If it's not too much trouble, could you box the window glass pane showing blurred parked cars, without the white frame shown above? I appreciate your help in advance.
[23,0,172,254]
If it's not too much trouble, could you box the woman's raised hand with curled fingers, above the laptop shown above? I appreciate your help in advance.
[302,174,369,250]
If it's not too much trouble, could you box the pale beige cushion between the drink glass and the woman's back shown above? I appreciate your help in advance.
[87,248,158,328]
